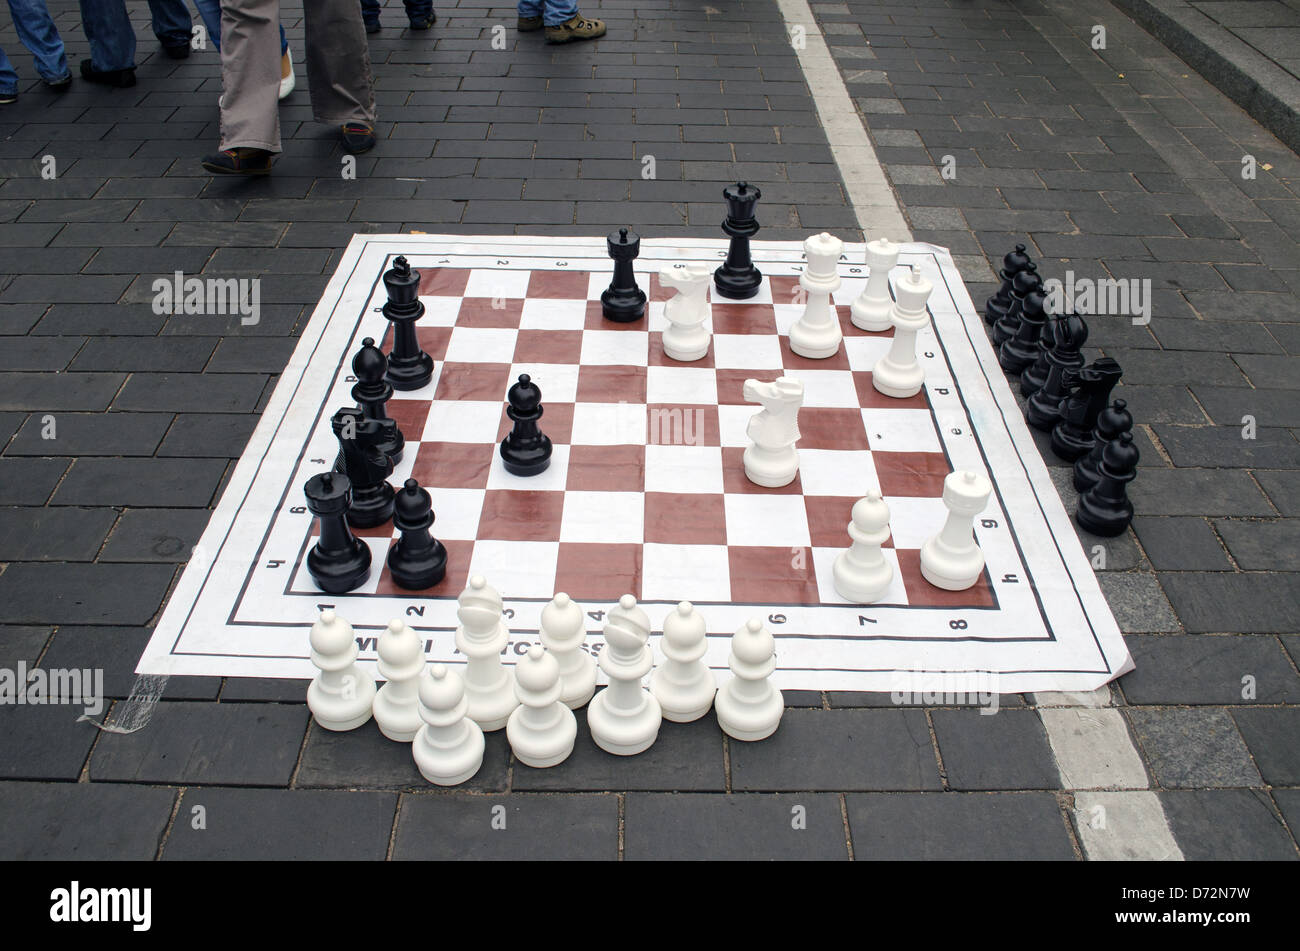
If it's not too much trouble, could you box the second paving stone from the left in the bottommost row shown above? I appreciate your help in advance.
[163,787,398,861]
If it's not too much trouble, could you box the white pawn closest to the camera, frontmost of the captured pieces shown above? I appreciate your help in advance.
[411,664,485,786]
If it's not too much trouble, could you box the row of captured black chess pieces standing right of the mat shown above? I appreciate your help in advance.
[984,244,1139,537]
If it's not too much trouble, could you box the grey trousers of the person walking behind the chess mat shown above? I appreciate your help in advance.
[221,0,374,152]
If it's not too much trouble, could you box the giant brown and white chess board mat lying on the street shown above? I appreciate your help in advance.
[138,235,1132,692]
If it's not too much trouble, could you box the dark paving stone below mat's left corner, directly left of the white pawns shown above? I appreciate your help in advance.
[90,700,308,786]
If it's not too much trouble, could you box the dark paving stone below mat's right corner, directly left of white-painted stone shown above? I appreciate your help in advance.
[931,709,1061,790]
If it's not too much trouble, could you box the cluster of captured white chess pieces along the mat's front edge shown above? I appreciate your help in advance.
[307,576,785,786]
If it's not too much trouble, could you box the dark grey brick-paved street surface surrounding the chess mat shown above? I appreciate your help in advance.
[0,0,1300,859]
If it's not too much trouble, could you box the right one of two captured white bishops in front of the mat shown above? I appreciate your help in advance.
[586,595,663,756]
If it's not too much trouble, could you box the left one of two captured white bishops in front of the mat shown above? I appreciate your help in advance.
[456,574,519,733]
